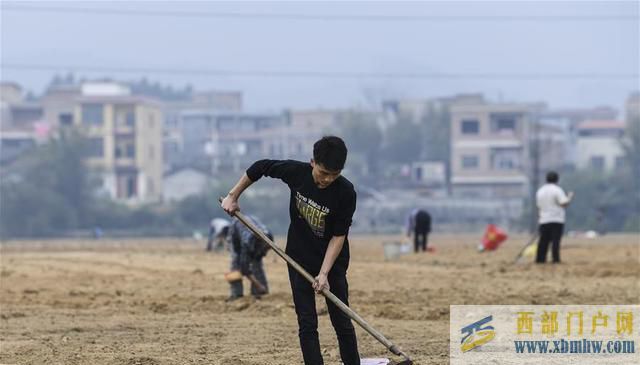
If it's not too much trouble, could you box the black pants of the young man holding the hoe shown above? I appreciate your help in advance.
[289,267,360,365]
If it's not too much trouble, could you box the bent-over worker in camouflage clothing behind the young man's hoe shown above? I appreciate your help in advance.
[226,216,273,301]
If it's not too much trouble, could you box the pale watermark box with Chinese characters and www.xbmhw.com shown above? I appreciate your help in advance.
[449,304,640,365]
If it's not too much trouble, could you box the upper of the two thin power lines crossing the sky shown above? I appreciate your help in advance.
[2,4,640,22]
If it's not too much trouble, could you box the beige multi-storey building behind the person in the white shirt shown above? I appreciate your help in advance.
[450,102,540,198]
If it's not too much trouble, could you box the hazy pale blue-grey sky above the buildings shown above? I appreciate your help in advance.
[1,1,640,111]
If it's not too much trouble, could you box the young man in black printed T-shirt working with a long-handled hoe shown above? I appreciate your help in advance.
[222,136,360,365]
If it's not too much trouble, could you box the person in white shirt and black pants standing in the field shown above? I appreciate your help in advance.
[536,171,573,264]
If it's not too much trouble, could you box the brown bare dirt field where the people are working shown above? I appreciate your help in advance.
[0,235,640,365]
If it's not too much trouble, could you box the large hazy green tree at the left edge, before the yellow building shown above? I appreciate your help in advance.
[0,131,92,236]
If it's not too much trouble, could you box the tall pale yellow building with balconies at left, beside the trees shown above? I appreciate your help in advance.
[73,85,163,204]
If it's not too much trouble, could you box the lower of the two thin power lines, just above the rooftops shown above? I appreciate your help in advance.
[1,63,640,80]
